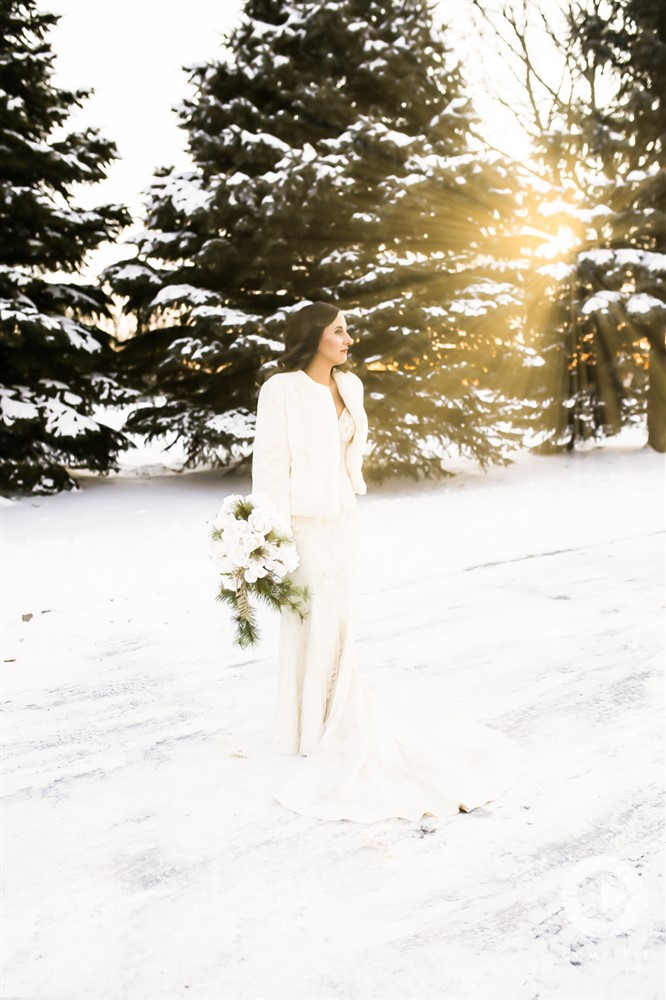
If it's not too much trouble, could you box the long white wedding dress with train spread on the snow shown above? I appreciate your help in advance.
[272,407,520,823]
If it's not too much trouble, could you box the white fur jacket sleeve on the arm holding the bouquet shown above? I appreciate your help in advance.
[252,376,291,528]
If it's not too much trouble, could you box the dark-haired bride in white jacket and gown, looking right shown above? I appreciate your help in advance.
[252,302,519,823]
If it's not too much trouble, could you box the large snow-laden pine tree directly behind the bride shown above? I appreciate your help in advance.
[106,0,523,478]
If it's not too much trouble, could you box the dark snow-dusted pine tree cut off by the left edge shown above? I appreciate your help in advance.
[0,0,130,496]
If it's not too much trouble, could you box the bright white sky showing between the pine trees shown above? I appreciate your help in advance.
[37,0,559,272]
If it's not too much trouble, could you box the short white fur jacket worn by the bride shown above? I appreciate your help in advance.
[252,370,368,521]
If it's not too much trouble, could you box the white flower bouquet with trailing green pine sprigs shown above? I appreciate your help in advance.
[210,493,310,649]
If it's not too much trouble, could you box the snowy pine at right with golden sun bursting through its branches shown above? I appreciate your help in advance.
[510,0,666,451]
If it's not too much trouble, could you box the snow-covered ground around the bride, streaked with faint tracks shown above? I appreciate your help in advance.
[2,432,664,1000]
